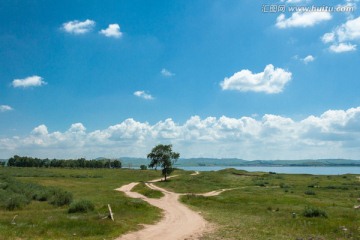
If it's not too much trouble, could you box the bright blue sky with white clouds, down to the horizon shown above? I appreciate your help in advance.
[0,0,360,159]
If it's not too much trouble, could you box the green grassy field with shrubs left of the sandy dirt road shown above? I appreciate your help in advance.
[0,167,161,240]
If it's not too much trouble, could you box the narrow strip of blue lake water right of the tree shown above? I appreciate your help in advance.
[176,166,360,175]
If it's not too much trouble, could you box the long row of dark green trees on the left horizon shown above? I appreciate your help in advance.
[7,155,121,168]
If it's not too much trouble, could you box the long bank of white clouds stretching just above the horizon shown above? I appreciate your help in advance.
[0,107,360,159]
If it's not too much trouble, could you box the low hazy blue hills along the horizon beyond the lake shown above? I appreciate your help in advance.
[120,157,360,167]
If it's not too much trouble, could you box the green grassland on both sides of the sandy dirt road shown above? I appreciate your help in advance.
[0,168,360,240]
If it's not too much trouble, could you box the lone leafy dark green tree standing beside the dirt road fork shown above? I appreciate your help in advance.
[147,144,180,181]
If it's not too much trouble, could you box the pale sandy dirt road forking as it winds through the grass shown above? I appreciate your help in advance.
[116,172,214,240]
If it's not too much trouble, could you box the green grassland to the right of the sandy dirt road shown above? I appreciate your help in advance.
[157,169,360,240]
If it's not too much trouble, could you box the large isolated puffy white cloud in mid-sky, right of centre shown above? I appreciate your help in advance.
[220,64,292,94]
